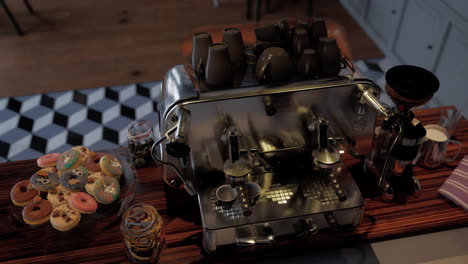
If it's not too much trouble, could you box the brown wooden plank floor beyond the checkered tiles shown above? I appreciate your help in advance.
[0,0,382,97]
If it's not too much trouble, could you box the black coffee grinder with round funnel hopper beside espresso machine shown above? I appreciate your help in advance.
[358,65,439,203]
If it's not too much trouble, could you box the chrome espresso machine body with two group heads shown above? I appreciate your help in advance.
[157,65,379,252]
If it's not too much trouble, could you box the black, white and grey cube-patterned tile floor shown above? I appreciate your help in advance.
[0,60,383,162]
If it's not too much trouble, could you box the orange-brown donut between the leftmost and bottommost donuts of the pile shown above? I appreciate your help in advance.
[23,196,54,225]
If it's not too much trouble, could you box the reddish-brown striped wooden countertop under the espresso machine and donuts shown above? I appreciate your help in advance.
[0,108,468,263]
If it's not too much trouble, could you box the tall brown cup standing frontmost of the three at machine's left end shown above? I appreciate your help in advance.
[205,43,232,88]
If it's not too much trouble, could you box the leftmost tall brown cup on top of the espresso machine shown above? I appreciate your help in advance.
[192,32,213,75]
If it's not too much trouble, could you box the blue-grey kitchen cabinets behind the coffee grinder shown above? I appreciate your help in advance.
[341,0,468,112]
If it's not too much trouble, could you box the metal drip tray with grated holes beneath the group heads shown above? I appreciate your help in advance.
[198,170,364,230]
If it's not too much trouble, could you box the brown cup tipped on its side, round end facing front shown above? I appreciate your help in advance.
[256,47,292,81]
